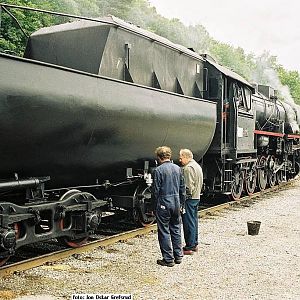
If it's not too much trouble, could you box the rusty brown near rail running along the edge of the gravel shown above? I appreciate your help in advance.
[0,180,294,277]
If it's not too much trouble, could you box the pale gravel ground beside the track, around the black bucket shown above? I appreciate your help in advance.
[0,180,300,300]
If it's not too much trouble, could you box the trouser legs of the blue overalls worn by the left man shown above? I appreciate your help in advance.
[156,197,183,262]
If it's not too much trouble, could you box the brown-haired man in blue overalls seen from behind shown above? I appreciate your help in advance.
[153,146,185,267]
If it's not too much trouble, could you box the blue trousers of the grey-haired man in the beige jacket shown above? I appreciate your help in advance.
[182,199,200,250]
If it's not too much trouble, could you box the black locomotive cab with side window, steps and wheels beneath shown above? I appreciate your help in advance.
[204,59,257,198]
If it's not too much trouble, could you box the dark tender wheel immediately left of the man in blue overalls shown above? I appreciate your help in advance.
[133,185,155,227]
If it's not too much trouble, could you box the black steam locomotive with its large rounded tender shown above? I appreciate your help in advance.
[0,5,300,264]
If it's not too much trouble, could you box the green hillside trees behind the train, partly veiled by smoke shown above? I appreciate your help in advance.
[0,0,300,103]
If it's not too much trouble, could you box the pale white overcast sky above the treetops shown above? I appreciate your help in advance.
[149,0,300,71]
